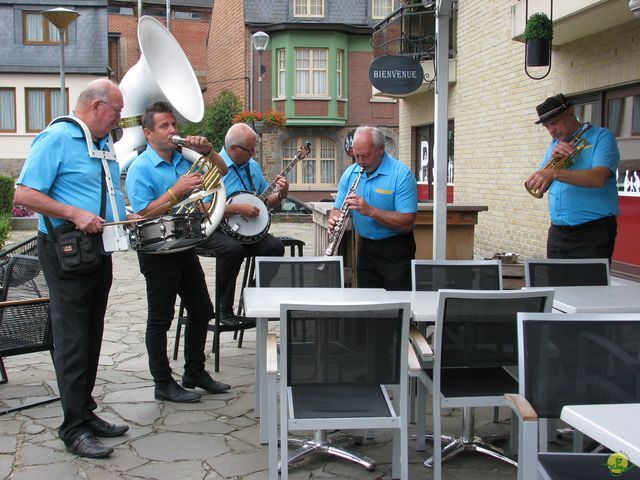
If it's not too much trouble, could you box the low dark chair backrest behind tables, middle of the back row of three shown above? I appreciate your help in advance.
[411,260,502,291]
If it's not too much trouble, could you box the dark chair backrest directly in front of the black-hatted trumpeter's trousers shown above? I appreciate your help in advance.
[524,258,610,287]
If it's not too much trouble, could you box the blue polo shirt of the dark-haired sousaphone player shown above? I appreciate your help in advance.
[125,145,191,213]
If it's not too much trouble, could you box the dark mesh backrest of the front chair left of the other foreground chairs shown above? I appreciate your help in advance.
[280,302,411,388]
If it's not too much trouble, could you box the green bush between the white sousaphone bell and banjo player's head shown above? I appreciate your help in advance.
[180,90,242,151]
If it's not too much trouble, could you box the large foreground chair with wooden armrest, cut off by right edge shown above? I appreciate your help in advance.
[506,313,640,480]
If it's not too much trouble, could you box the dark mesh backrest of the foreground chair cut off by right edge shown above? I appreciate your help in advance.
[518,313,640,418]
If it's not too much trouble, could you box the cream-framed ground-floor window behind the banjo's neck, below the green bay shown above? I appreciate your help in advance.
[282,137,338,188]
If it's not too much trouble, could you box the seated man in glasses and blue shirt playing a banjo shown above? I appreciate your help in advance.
[201,123,289,326]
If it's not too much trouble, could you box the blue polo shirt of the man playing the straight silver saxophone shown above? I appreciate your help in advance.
[335,152,418,240]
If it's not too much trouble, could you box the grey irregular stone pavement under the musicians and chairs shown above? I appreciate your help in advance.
[0,221,516,480]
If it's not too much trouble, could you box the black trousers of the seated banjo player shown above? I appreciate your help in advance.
[200,230,284,311]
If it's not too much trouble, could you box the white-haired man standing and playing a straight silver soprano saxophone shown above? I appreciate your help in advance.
[328,126,418,290]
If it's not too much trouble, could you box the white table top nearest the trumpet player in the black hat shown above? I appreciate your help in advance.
[553,285,640,313]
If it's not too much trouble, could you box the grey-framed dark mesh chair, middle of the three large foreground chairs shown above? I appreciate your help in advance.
[418,289,553,480]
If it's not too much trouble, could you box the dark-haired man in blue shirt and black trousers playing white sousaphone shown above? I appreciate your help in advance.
[125,102,230,402]
